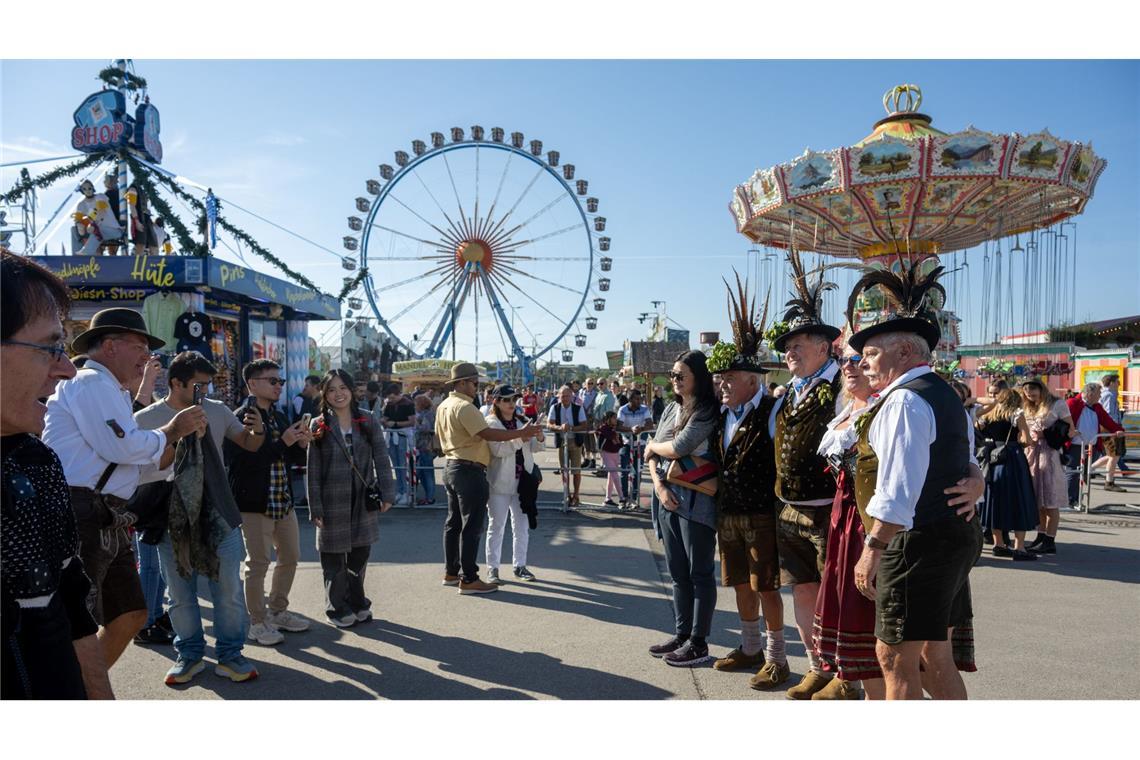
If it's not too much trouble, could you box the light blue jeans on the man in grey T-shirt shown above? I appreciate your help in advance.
[158,528,250,662]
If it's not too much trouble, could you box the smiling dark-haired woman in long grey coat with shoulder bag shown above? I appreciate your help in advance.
[308,369,396,628]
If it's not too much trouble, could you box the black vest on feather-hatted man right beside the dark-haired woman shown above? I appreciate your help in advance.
[713,397,776,514]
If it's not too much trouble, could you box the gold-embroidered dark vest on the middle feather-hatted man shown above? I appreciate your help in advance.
[775,373,842,501]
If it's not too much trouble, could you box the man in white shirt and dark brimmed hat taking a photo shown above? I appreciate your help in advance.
[43,309,206,668]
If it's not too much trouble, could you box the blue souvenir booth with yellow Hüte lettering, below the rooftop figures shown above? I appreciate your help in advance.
[32,255,340,407]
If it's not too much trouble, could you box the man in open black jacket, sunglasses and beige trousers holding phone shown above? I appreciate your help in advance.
[226,359,312,646]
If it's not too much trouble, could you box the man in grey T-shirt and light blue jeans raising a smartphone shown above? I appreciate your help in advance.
[135,351,266,686]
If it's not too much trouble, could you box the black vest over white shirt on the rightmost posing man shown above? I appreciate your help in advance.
[855,373,970,528]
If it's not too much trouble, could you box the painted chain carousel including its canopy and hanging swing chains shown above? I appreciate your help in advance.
[730,84,1106,357]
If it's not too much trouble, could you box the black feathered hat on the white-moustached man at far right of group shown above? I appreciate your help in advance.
[847,255,946,351]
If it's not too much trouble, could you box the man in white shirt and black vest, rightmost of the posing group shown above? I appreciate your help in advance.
[850,332,985,700]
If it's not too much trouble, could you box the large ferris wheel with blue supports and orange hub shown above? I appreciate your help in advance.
[344,125,613,376]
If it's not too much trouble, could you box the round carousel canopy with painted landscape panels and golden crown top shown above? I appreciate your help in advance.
[730,84,1106,259]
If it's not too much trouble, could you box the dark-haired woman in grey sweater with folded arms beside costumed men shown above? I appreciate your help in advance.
[645,351,719,667]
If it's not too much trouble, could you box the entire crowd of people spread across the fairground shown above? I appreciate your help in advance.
[2,253,1124,700]
